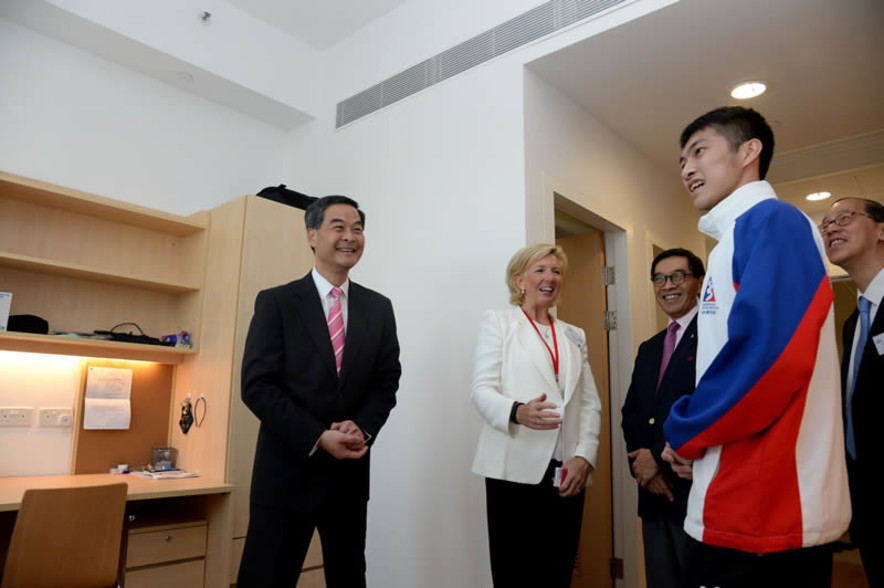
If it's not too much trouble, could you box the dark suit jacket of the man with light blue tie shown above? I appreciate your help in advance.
[841,300,884,536]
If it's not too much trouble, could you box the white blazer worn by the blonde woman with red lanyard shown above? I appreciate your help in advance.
[472,307,601,485]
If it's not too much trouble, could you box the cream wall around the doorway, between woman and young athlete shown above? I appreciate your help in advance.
[525,70,705,586]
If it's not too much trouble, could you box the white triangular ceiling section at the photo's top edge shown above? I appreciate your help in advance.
[223,0,406,50]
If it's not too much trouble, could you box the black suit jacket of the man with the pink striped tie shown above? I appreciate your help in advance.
[242,274,401,512]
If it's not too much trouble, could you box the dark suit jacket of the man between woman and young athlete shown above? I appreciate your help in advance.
[622,316,697,522]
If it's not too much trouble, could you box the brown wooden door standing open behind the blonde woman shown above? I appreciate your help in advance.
[556,231,613,588]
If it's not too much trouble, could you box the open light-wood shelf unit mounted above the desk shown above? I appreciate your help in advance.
[0,172,208,364]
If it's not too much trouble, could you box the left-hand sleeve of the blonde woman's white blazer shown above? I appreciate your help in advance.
[472,310,513,433]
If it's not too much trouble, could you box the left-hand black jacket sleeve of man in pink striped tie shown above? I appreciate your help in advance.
[242,290,325,457]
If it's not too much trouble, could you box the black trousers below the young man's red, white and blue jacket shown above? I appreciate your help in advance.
[684,537,832,588]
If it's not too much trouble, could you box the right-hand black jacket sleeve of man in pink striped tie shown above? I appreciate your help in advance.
[353,298,402,443]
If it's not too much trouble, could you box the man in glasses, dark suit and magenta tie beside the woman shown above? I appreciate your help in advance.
[623,249,705,588]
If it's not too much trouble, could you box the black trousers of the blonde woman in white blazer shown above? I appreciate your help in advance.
[485,464,585,588]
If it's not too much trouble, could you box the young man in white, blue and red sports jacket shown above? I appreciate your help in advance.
[663,106,850,588]
